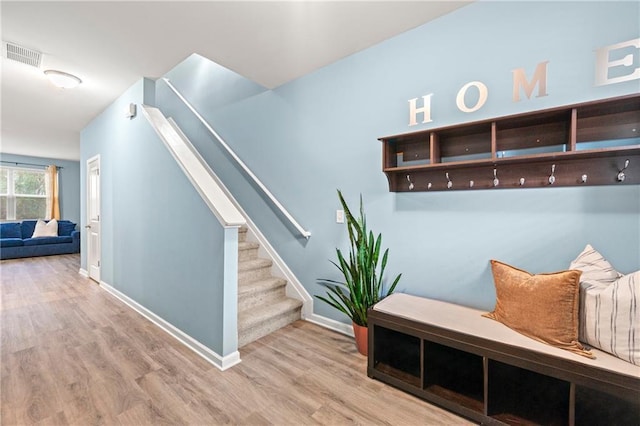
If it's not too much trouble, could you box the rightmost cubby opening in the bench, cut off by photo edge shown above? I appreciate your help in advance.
[575,386,640,426]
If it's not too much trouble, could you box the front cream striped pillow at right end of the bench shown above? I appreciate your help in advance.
[580,271,640,365]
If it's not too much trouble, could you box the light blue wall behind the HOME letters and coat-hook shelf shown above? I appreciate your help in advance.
[156,2,640,322]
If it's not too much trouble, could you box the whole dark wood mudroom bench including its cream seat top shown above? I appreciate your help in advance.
[367,293,640,425]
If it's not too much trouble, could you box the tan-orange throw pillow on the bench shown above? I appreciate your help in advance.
[483,260,593,358]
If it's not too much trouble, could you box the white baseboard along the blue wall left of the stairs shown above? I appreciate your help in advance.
[100,281,240,371]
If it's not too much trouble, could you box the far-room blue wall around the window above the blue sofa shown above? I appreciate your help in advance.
[0,154,81,224]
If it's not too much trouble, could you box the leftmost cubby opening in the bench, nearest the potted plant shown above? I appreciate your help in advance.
[373,326,420,387]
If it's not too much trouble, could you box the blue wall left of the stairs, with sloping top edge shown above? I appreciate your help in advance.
[81,79,229,356]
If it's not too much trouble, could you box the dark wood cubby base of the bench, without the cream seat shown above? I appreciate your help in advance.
[367,309,640,426]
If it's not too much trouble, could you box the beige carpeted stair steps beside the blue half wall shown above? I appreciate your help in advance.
[238,227,302,348]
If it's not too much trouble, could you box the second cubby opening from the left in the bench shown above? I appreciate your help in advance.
[424,341,484,413]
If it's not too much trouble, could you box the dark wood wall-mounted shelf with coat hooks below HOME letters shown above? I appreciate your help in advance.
[379,94,640,192]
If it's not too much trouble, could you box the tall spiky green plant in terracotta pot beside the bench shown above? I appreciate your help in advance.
[316,190,402,355]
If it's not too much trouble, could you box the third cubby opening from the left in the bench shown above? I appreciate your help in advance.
[487,360,571,425]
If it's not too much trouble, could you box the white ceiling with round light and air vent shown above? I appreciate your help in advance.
[0,0,470,160]
